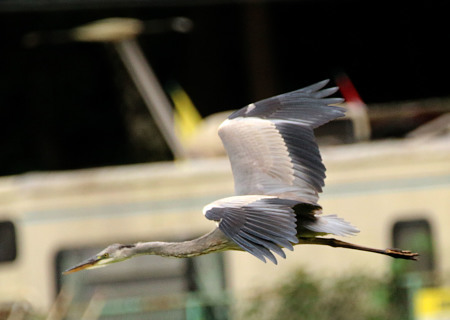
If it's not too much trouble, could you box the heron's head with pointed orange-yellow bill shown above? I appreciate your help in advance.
[63,243,135,274]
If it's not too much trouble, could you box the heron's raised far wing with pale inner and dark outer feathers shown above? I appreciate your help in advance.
[219,80,345,203]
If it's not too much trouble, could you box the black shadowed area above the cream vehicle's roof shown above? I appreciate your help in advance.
[0,1,450,175]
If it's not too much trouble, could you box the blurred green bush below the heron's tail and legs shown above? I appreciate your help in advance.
[238,271,406,320]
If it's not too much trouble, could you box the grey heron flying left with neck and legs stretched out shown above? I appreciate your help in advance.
[64,80,418,274]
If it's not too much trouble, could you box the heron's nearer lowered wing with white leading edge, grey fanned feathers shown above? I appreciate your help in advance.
[204,196,298,264]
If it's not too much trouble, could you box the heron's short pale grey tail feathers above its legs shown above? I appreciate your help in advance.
[303,214,359,236]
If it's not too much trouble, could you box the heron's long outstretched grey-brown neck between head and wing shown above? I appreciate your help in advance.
[135,228,236,258]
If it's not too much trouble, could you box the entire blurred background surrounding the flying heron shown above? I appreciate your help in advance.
[0,0,450,319]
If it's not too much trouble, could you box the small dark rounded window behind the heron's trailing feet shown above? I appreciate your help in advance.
[393,219,434,274]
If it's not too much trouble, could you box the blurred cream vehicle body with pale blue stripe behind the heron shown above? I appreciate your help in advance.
[0,137,450,319]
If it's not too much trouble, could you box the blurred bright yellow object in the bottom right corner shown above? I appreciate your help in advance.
[414,288,450,320]
